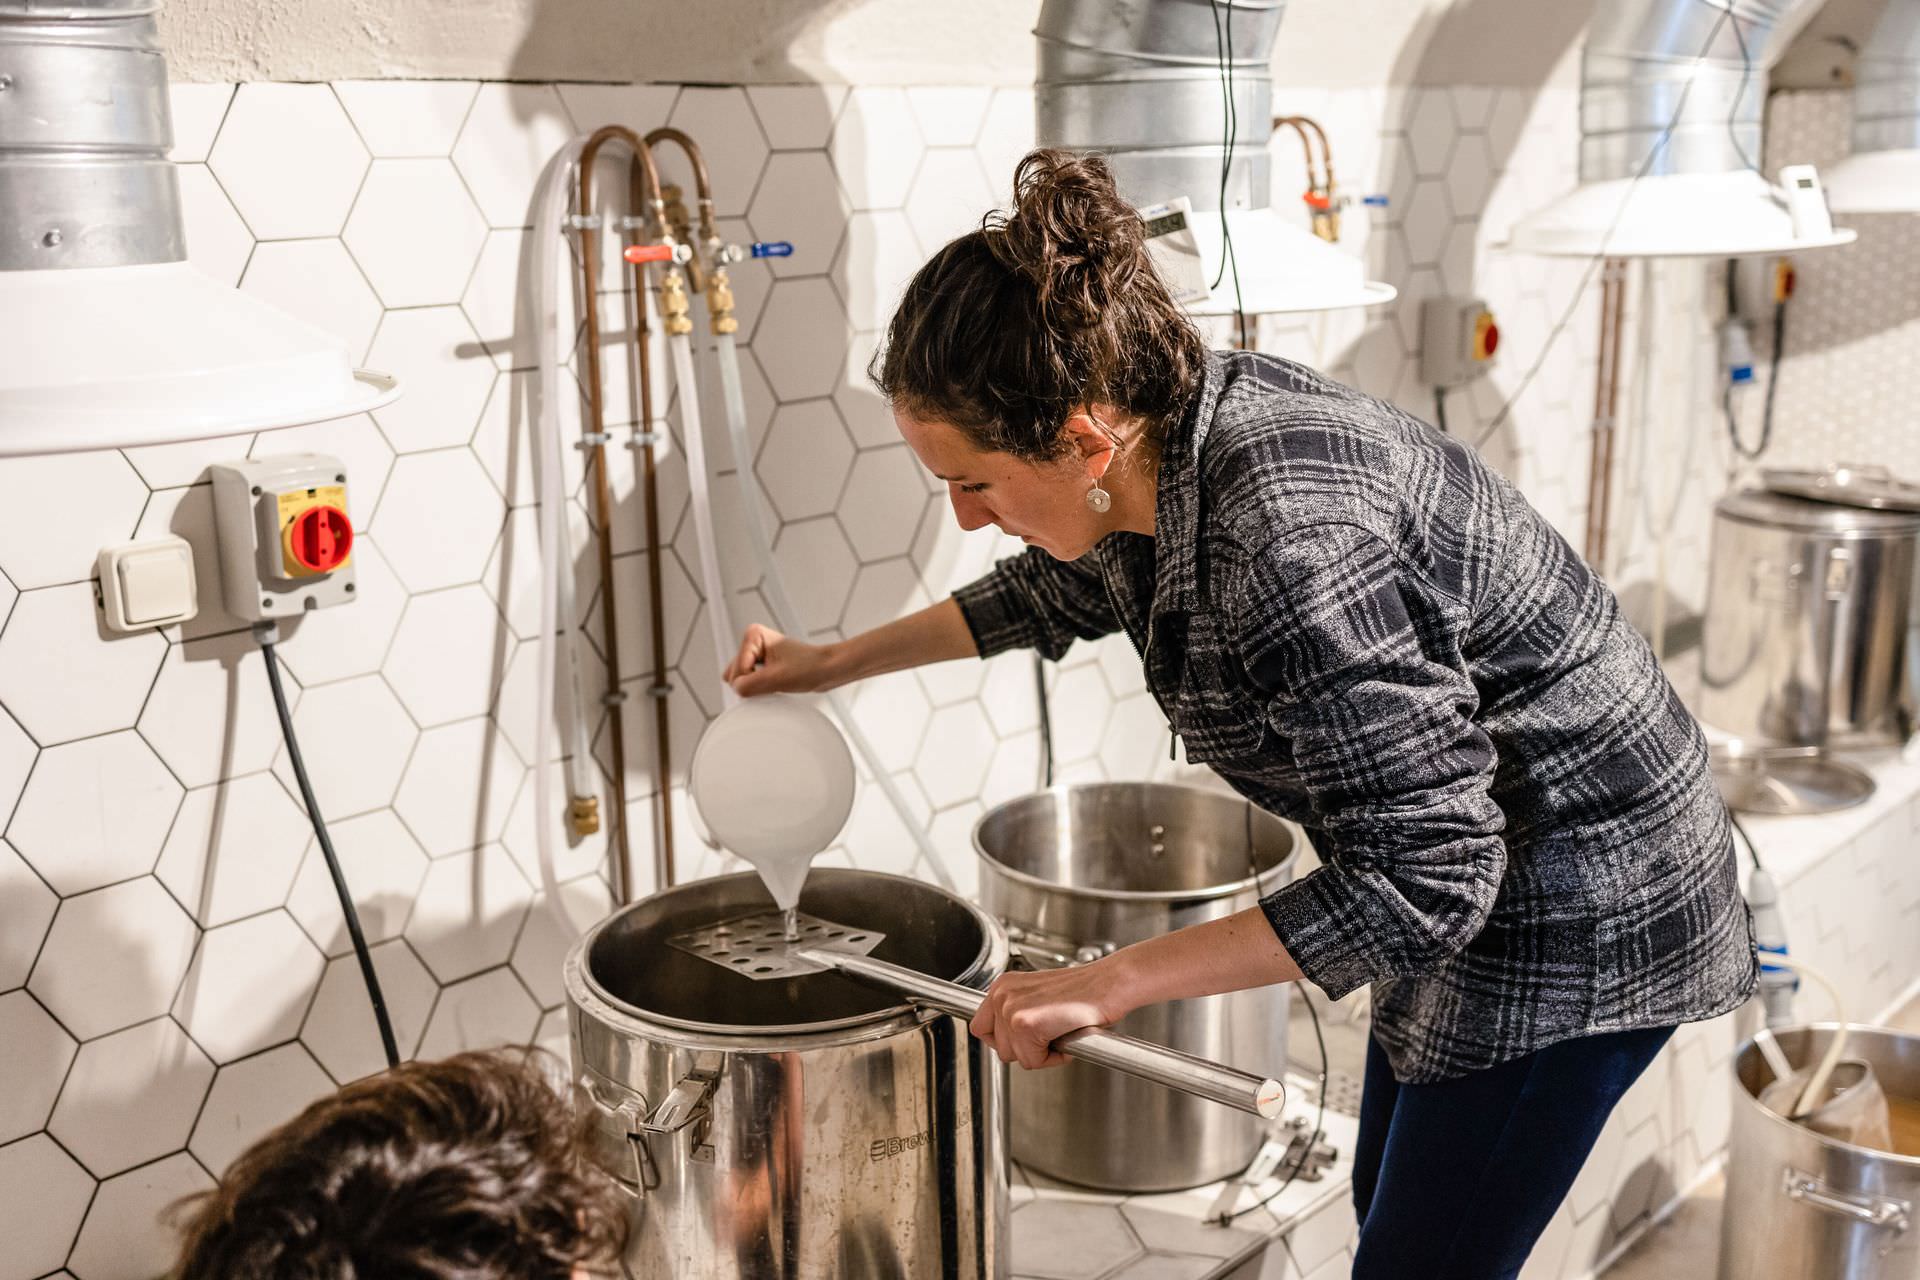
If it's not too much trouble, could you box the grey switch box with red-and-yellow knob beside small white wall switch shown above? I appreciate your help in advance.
[211,453,355,622]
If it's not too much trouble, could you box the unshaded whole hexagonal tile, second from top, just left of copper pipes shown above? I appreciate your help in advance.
[340,159,486,310]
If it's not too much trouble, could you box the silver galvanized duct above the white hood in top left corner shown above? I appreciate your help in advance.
[0,0,186,271]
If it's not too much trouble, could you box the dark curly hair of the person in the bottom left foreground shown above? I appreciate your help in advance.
[173,1052,628,1280]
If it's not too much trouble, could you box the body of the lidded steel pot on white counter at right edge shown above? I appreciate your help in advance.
[1699,489,1920,747]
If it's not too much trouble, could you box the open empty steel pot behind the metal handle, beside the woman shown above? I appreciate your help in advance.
[973,783,1296,1192]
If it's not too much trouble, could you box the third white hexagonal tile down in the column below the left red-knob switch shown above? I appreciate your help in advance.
[173,912,324,1063]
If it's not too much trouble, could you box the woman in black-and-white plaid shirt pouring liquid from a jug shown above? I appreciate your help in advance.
[728,152,1755,1280]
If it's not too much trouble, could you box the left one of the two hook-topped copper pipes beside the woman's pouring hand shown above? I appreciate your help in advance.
[568,125,660,904]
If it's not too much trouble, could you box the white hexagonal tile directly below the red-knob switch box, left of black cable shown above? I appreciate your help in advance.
[140,635,288,787]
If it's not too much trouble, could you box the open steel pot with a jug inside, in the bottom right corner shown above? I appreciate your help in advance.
[1720,1025,1920,1280]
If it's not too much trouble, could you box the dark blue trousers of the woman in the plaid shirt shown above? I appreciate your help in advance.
[1354,1027,1674,1280]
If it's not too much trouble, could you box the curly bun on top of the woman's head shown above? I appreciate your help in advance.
[985,148,1148,328]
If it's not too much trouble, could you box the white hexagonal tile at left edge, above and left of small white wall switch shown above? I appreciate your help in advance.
[0,451,146,591]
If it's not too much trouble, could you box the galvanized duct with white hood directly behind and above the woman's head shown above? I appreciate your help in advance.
[1033,0,1394,315]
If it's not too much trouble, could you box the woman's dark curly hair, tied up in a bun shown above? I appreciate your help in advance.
[868,150,1206,461]
